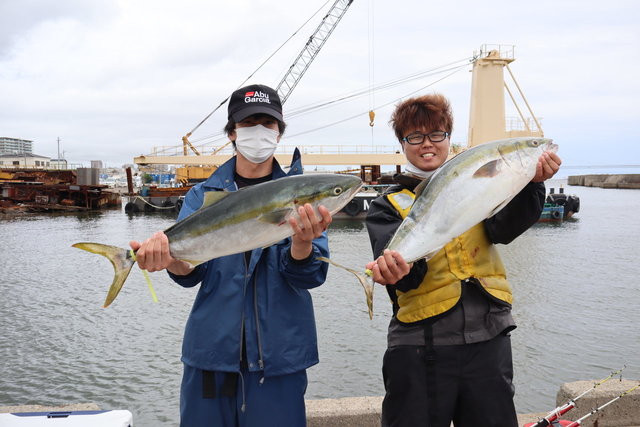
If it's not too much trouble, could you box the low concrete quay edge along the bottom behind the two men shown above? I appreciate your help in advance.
[0,379,640,427]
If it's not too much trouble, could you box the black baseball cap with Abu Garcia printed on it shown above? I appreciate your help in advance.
[228,85,284,123]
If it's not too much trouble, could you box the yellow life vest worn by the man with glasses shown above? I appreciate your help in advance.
[387,189,513,323]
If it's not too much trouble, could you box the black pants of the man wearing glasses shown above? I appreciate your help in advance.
[382,335,518,427]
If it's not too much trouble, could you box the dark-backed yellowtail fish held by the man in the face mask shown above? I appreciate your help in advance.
[73,174,362,307]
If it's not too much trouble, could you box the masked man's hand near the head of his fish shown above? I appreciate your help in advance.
[289,203,332,260]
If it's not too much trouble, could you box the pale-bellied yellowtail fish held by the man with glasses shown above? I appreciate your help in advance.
[323,137,558,316]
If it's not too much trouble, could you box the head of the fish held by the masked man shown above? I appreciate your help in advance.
[296,174,362,215]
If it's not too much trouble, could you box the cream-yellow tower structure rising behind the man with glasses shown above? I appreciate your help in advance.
[468,45,543,147]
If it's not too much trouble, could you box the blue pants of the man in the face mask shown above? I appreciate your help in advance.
[180,365,307,427]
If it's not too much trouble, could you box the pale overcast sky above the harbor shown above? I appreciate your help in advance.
[0,0,640,171]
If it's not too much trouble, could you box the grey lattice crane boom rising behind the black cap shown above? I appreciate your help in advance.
[276,0,353,104]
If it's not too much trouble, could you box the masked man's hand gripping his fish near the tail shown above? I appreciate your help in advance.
[129,231,194,276]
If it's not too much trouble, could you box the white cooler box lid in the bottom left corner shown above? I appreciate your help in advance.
[0,410,133,427]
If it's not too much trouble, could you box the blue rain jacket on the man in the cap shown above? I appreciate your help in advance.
[169,149,329,376]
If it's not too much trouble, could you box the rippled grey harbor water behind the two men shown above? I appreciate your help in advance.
[0,180,640,427]
